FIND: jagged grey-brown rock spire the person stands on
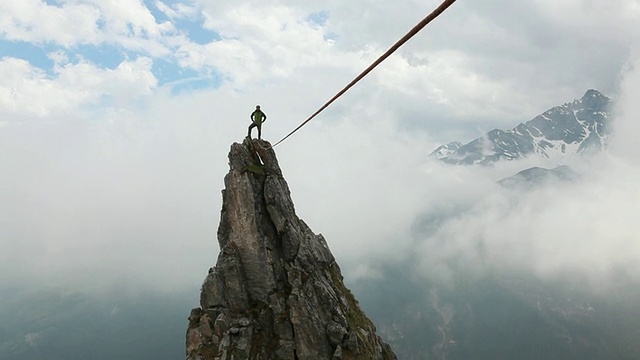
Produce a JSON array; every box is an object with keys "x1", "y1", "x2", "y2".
[{"x1": 186, "y1": 139, "x2": 396, "y2": 360}]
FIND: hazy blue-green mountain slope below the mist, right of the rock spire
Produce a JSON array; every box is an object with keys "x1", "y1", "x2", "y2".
[{"x1": 354, "y1": 258, "x2": 640, "y2": 360}]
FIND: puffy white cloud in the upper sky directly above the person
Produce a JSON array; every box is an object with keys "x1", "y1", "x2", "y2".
[{"x1": 178, "y1": 4, "x2": 342, "y2": 86}]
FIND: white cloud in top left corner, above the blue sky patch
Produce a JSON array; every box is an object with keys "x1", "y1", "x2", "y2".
[{"x1": 0, "y1": 0, "x2": 176, "y2": 56}]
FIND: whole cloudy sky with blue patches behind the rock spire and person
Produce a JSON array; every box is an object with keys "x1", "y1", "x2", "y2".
[{"x1": 0, "y1": 0, "x2": 640, "y2": 299}]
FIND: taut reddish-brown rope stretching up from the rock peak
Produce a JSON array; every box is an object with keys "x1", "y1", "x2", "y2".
[{"x1": 271, "y1": 0, "x2": 456, "y2": 148}]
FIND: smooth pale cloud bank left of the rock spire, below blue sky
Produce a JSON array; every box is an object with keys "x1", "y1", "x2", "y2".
[{"x1": 0, "y1": 90, "x2": 230, "y2": 289}]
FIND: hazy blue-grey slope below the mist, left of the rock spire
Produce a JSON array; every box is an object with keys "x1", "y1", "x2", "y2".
[{"x1": 0, "y1": 285, "x2": 193, "y2": 360}]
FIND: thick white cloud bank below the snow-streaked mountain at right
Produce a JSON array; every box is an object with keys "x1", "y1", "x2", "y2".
[{"x1": 412, "y1": 158, "x2": 640, "y2": 290}]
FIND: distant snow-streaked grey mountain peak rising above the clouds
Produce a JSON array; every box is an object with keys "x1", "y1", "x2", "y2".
[{"x1": 430, "y1": 90, "x2": 612, "y2": 165}]
